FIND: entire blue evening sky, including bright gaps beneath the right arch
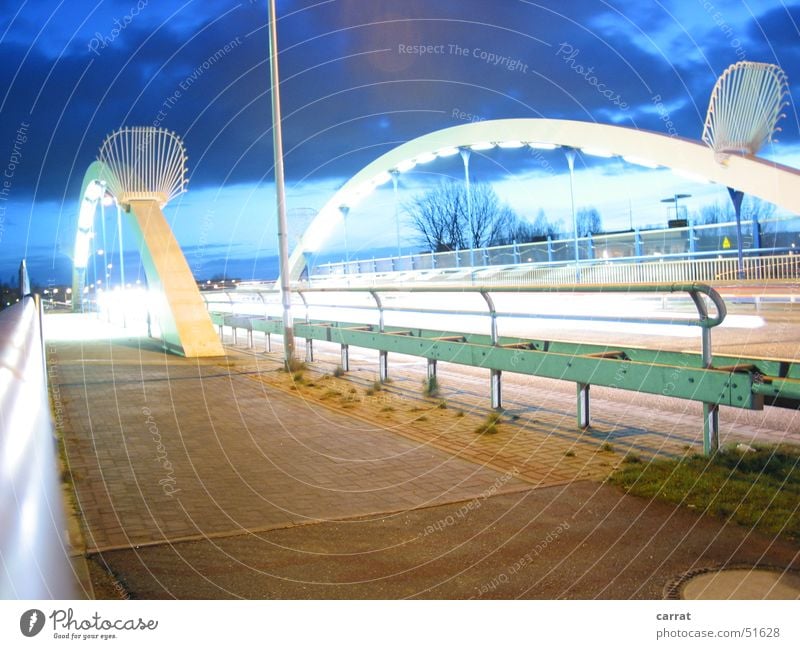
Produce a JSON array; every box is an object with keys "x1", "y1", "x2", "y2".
[{"x1": 0, "y1": 0, "x2": 800, "y2": 283}]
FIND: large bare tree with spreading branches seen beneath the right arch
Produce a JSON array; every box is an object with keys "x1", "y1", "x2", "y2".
[{"x1": 403, "y1": 181, "x2": 519, "y2": 252}]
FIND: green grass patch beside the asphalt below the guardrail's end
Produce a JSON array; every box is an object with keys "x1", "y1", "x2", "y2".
[{"x1": 609, "y1": 446, "x2": 800, "y2": 541}]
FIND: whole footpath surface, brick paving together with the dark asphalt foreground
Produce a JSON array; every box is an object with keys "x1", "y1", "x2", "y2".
[{"x1": 48, "y1": 318, "x2": 800, "y2": 598}]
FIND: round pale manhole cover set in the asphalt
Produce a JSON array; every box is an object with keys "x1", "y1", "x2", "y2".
[{"x1": 677, "y1": 568, "x2": 800, "y2": 599}]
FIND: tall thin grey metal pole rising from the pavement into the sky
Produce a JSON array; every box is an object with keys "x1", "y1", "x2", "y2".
[{"x1": 269, "y1": 0, "x2": 294, "y2": 370}]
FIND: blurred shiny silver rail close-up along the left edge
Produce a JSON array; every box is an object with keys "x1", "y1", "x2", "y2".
[{"x1": 0, "y1": 286, "x2": 75, "y2": 599}]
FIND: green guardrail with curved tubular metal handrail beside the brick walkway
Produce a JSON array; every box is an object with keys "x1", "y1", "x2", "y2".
[{"x1": 200, "y1": 283, "x2": 800, "y2": 452}]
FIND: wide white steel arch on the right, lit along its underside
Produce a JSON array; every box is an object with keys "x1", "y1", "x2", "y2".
[{"x1": 289, "y1": 118, "x2": 800, "y2": 281}]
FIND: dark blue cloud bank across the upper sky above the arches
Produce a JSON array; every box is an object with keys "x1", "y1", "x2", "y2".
[{"x1": 0, "y1": 0, "x2": 800, "y2": 274}]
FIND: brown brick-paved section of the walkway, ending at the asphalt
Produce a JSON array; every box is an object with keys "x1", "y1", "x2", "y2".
[{"x1": 50, "y1": 334, "x2": 528, "y2": 552}]
